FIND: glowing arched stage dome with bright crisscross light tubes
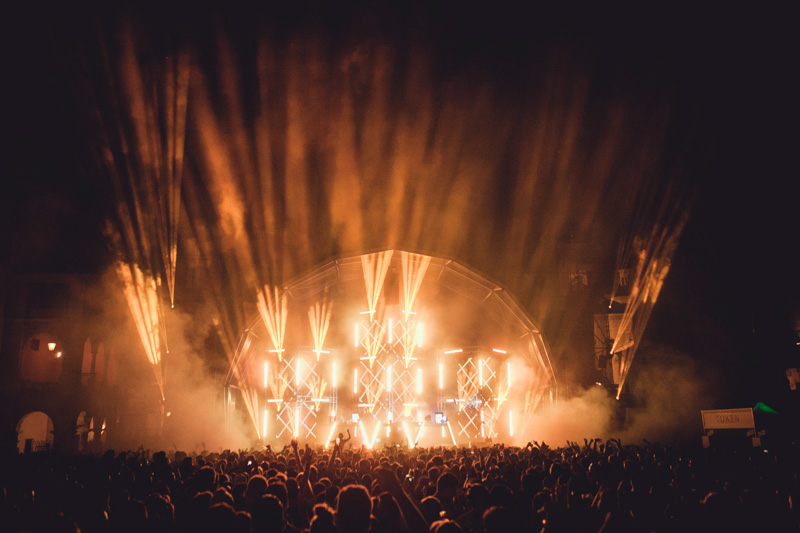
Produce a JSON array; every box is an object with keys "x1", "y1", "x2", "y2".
[{"x1": 224, "y1": 250, "x2": 557, "y2": 448}]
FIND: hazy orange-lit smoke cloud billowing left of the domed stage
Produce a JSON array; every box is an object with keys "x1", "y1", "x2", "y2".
[{"x1": 72, "y1": 268, "x2": 251, "y2": 452}]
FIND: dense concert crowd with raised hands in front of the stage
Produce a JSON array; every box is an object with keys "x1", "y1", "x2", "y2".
[{"x1": 0, "y1": 436, "x2": 800, "y2": 533}]
